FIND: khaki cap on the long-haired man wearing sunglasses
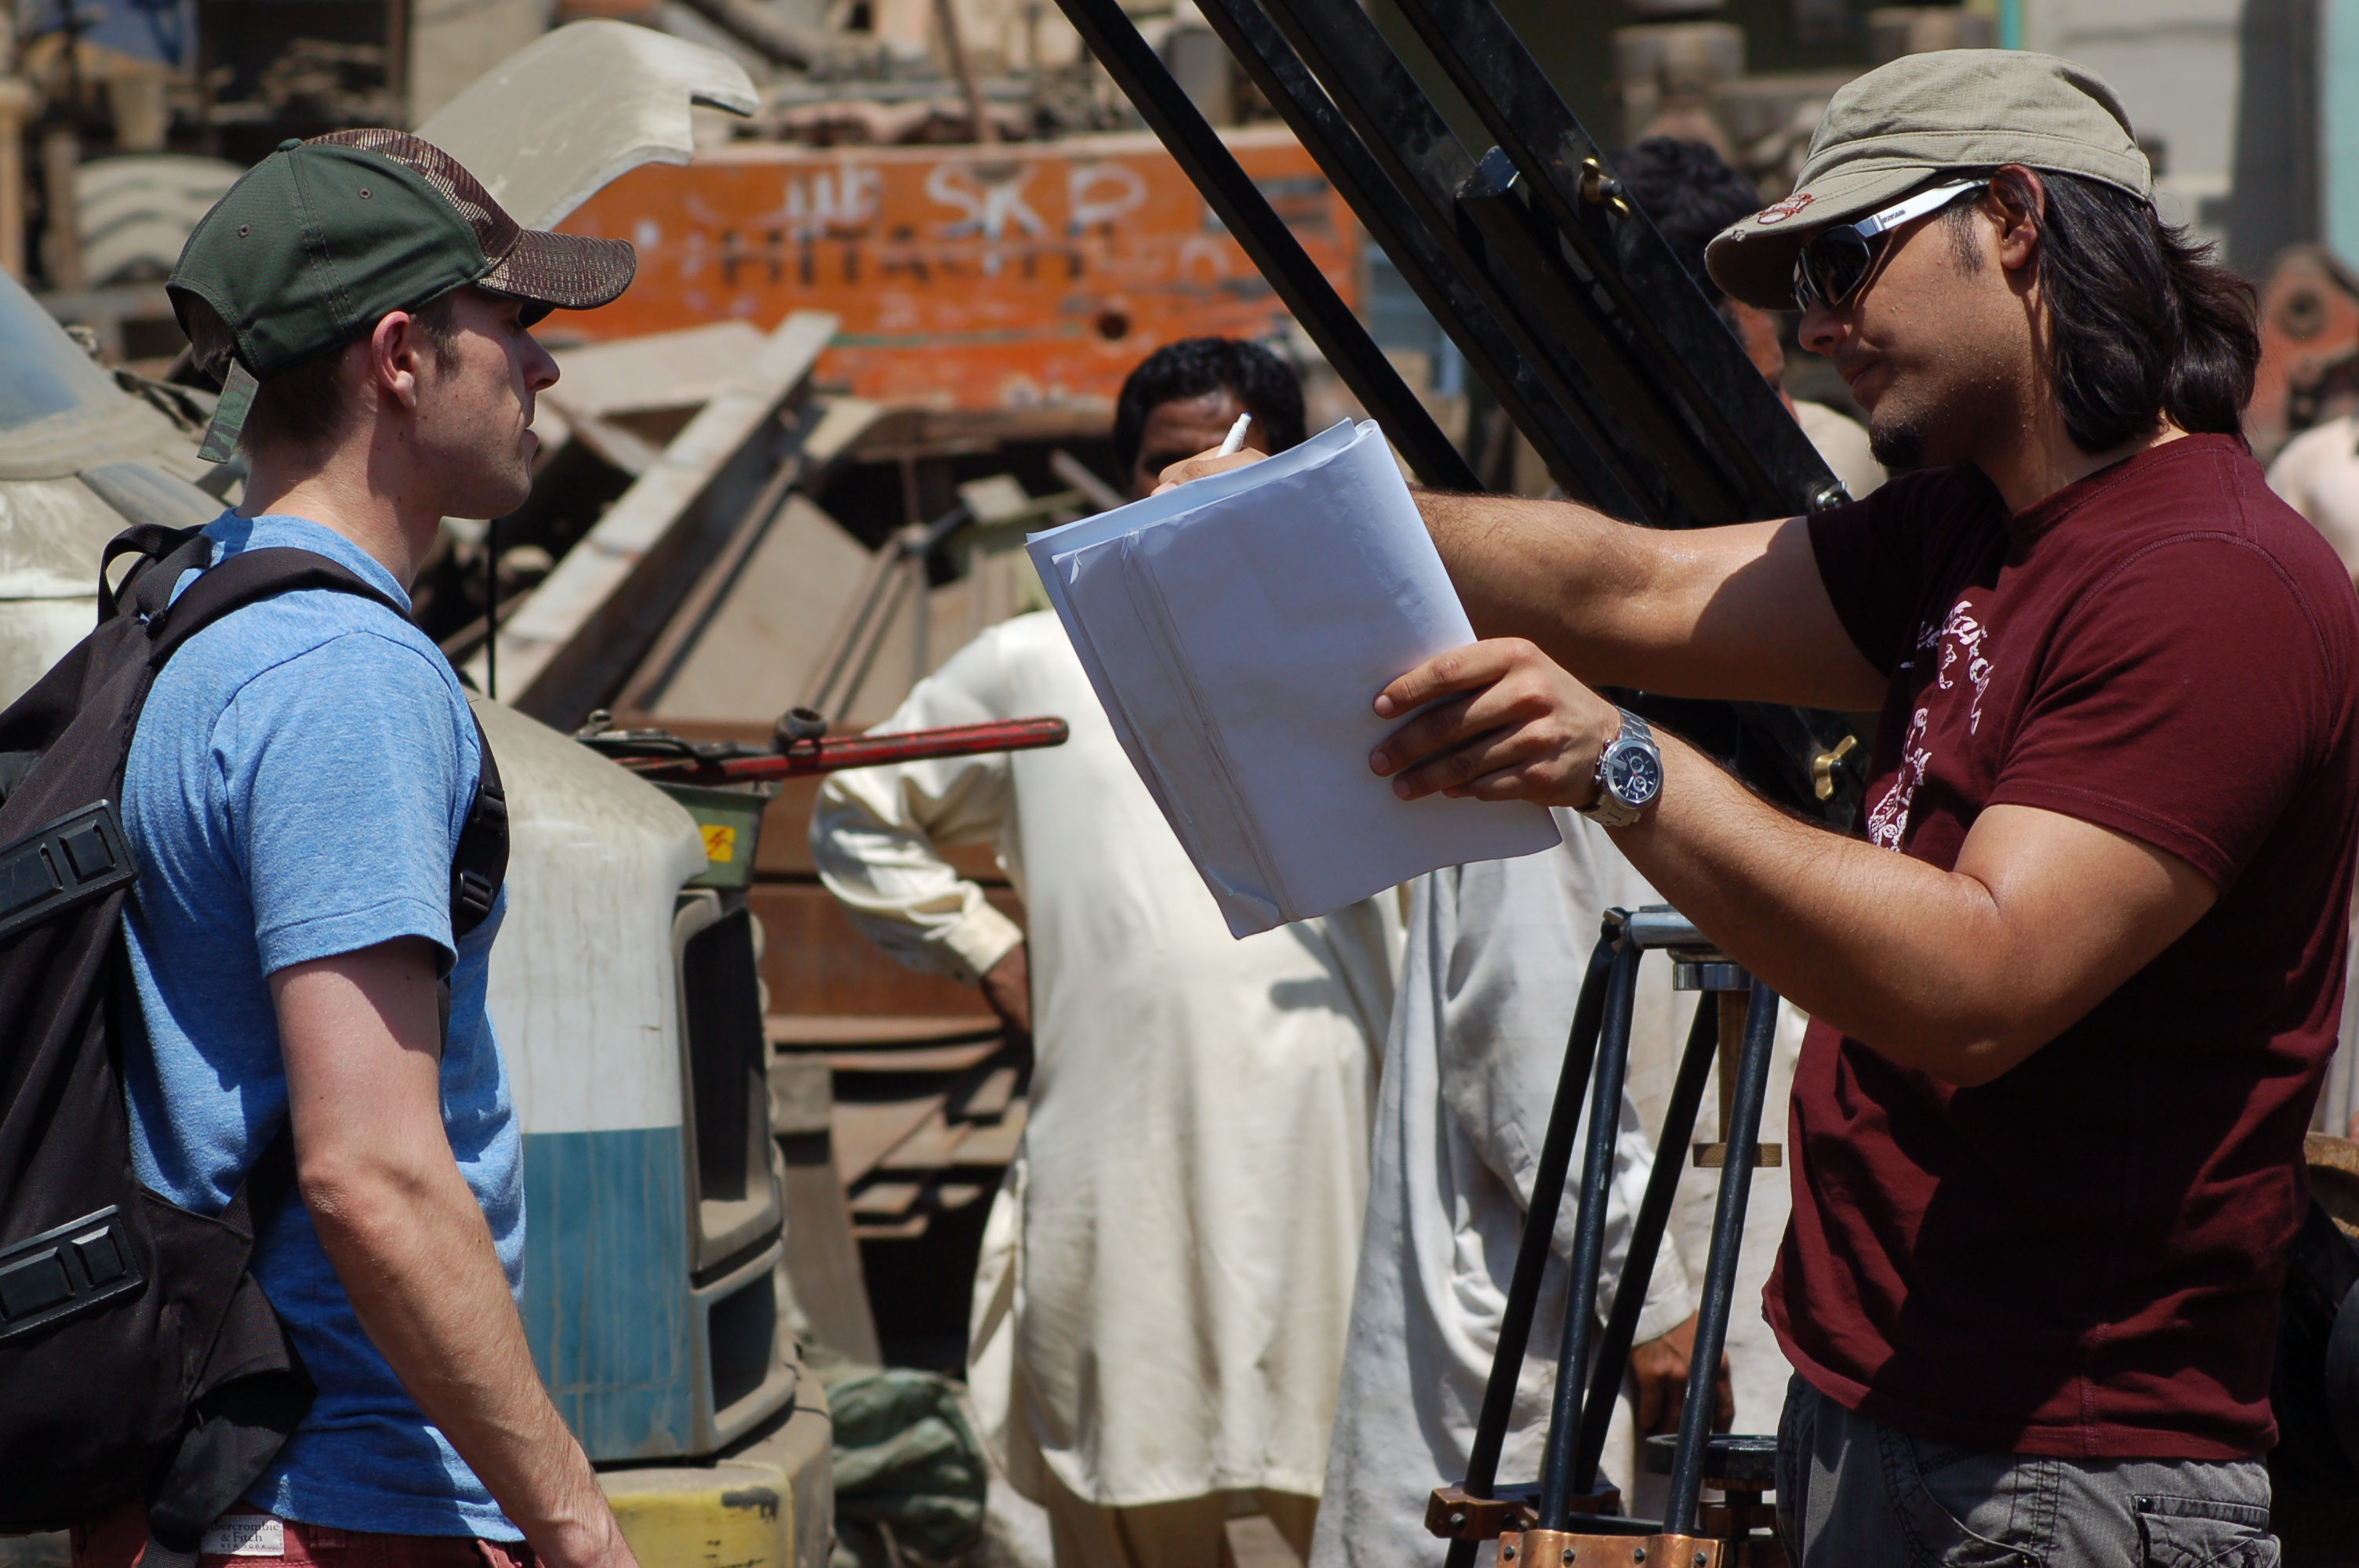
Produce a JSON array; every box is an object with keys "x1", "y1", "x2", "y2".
[{"x1": 1703, "y1": 49, "x2": 2154, "y2": 311}]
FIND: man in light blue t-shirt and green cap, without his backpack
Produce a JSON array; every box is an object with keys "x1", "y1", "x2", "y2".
[{"x1": 75, "y1": 129, "x2": 634, "y2": 1568}]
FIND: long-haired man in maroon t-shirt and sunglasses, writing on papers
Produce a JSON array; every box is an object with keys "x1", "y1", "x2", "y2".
[{"x1": 1170, "y1": 49, "x2": 2359, "y2": 1568}]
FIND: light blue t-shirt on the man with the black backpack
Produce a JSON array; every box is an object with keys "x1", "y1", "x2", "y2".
[{"x1": 122, "y1": 514, "x2": 524, "y2": 1540}]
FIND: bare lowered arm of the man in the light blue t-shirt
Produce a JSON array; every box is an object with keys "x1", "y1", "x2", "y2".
[{"x1": 271, "y1": 936, "x2": 637, "y2": 1568}]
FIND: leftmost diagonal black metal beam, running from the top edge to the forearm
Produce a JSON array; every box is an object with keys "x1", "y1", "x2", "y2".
[{"x1": 1057, "y1": 0, "x2": 1481, "y2": 491}]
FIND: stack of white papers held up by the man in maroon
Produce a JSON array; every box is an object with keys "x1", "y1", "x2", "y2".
[{"x1": 1026, "y1": 422, "x2": 1559, "y2": 936}]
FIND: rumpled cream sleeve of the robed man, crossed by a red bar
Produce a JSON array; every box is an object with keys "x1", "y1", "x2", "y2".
[{"x1": 812, "y1": 634, "x2": 1023, "y2": 981}]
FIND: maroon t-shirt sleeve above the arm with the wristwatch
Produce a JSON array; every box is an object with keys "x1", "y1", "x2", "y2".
[{"x1": 1989, "y1": 535, "x2": 2335, "y2": 889}]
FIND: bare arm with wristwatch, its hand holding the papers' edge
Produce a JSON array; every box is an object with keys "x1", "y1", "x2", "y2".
[{"x1": 1371, "y1": 639, "x2": 2220, "y2": 1084}]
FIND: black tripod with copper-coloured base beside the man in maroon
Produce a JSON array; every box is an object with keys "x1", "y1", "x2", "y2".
[{"x1": 1425, "y1": 908, "x2": 1786, "y2": 1568}]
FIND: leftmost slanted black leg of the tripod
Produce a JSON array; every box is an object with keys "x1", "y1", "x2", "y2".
[{"x1": 1448, "y1": 910, "x2": 1623, "y2": 1568}]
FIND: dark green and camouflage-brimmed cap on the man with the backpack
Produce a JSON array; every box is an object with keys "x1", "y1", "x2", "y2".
[{"x1": 165, "y1": 129, "x2": 639, "y2": 457}]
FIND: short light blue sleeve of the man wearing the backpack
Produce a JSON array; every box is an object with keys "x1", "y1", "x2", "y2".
[{"x1": 213, "y1": 632, "x2": 479, "y2": 974}]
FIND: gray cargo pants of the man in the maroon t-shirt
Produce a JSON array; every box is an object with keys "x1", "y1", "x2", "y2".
[{"x1": 1776, "y1": 1377, "x2": 2277, "y2": 1568}]
